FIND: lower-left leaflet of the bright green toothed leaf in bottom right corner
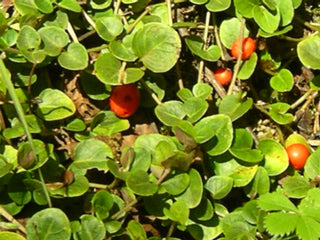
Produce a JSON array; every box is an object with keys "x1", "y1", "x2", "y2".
[{"x1": 264, "y1": 212, "x2": 299, "y2": 236}]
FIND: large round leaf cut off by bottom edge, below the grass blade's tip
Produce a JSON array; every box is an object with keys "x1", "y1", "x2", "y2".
[{"x1": 26, "y1": 208, "x2": 71, "y2": 240}]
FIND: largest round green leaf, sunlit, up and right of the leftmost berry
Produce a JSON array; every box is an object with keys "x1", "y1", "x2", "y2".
[{"x1": 132, "y1": 22, "x2": 181, "y2": 72}]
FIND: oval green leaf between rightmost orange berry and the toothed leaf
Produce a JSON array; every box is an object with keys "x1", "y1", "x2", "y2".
[{"x1": 283, "y1": 175, "x2": 311, "y2": 198}]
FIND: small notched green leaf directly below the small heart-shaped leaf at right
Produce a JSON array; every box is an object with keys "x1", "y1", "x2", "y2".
[{"x1": 269, "y1": 102, "x2": 293, "y2": 125}]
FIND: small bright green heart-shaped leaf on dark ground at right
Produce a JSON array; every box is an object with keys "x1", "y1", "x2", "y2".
[{"x1": 270, "y1": 69, "x2": 293, "y2": 92}]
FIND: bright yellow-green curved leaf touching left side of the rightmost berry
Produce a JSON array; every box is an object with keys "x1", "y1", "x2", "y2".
[{"x1": 258, "y1": 138, "x2": 289, "y2": 176}]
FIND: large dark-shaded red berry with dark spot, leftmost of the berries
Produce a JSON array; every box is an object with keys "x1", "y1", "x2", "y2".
[{"x1": 109, "y1": 84, "x2": 140, "y2": 118}]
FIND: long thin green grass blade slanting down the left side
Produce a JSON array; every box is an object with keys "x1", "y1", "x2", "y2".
[{"x1": 0, "y1": 58, "x2": 52, "y2": 207}]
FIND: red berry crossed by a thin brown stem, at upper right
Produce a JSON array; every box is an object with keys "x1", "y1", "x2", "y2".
[{"x1": 231, "y1": 37, "x2": 256, "y2": 60}]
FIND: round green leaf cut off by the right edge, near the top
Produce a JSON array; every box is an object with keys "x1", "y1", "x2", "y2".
[{"x1": 297, "y1": 36, "x2": 320, "y2": 69}]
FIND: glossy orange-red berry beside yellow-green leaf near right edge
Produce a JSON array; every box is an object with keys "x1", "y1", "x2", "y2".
[{"x1": 286, "y1": 143, "x2": 309, "y2": 170}]
